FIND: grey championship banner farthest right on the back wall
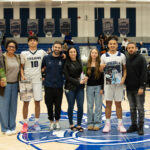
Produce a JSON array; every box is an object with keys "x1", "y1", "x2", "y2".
[{"x1": 118, "y1": 18, "x2": 130, "y2": 35}]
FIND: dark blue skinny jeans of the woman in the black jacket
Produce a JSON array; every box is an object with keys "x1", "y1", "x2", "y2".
[{"x1": 65, "y1": 88, "x2": 84, "y2": 126}]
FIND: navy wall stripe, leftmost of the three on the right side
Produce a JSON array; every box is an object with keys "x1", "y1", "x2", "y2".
[{"x1": 95, "y1": 8, "x2": 104, "y2": 36}]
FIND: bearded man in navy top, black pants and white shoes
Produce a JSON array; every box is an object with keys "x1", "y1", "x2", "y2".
[{"x1": 42, "y1": 41, "x2": 64, "y2": 130}]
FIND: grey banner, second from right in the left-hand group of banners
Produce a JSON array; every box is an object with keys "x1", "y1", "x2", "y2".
[{"x1": 43, "y1": 19, "x2": 55, "y2": 35}]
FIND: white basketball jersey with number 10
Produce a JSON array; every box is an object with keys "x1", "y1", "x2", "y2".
[{"x1": 20, "y1": 49, "x2": 47, "y2": 83}]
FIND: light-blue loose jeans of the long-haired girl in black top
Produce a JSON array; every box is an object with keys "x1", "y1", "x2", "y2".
[{"x1": 86, "y1": 85, "x2": 102, "y2": 127}]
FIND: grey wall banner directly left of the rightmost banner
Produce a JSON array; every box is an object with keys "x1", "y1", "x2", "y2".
[{"x1": 102, "y1": 18, "x2": 114, "y2": 35}]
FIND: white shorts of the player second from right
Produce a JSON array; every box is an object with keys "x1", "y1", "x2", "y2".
[{"x1": 104, "y1": 84, "x2": 125, "y2": 101}]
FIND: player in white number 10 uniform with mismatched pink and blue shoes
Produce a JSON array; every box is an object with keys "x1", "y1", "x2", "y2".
[{"x1": 21, "y1": 35, "x2": 47, "y2": 133}]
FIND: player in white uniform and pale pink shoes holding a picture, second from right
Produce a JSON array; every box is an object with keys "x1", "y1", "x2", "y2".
[{"x1": 100, "y1": 37, "x2": 126, "y2": 132}]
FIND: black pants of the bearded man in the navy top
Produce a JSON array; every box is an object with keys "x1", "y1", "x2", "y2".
[{"x1": 45, "y1": 87, "x2": 63, "y2": 121}]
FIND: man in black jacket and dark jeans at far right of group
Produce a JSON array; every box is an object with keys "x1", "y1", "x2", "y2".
[{"x1": 125, "y1": 42, "x2": 147, "y2": 135}]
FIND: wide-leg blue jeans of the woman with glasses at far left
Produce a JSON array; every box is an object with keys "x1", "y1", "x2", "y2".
[{"x1": 0, "y1": 83, "x2": 18, "y2": 132}]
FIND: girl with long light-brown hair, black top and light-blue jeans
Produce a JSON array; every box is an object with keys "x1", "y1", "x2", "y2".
[{"x1": 86, "y1": 49, "x2": 104, "y2": 130}]
